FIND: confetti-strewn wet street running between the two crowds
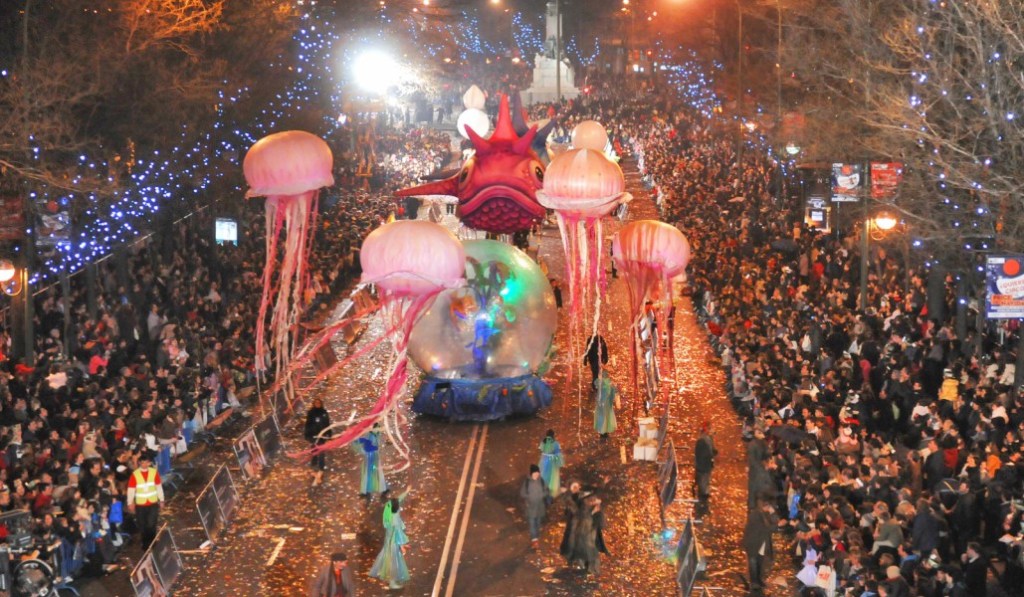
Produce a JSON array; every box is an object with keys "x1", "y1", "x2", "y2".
[{"x1": 163, "y1": 158, "x2": 745, "y2": 597}]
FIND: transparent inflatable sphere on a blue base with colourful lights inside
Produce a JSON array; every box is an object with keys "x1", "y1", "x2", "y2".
[{"x1": 409, "y1": 241, "x2": 557, "y2": 421}]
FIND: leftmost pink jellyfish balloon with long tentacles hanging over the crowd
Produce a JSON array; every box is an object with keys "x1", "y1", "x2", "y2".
[{"x1": 242, "y1": 131, "x2": 334, "y2": 378}]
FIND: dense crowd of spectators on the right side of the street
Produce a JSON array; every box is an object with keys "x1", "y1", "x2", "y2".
[{"x1": 635, "y1": 93, "x2": 1024, "y2": 597}]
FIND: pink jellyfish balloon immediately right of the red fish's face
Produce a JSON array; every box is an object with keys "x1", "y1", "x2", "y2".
[{"x1": 537, "y1": 145, "x2": 633, "y2": 378}]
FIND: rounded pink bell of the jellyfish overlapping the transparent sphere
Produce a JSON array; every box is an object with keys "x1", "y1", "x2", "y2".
[{"x1": 359, "y1": 220, "x2": 466, "y2": 297}]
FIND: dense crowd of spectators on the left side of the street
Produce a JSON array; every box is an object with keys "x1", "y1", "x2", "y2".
[{"x1": 0, "y1": 122, "x2": 449, "y2": 577}]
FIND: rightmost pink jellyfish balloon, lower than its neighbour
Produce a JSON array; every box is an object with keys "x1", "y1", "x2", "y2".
[{"x1": 611, "y1": 220, "x2": 690, "y2": 417}]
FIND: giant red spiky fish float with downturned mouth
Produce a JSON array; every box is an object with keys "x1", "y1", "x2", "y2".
[{"x1": 395, "y1": 95, "x2": 547, "y2": 234}]
